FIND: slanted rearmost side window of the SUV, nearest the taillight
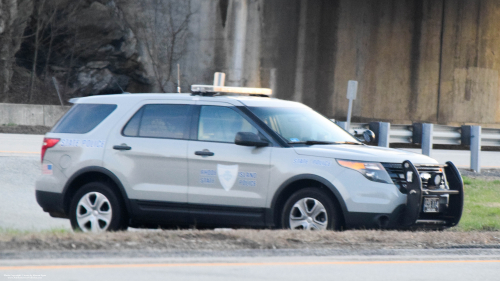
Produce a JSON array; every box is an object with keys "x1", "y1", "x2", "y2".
[{"x1": 51, "y1": 103, "x2": 116, "y2": 134}]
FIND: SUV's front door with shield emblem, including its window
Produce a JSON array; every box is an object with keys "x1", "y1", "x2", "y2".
[{"x1": 188, "y1": 102, "x2": 272, "y2": 225}]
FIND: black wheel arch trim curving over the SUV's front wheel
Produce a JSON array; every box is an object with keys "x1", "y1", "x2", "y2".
[{"x1": 266, "y1": 174, "x2": 348, "y2": 225}]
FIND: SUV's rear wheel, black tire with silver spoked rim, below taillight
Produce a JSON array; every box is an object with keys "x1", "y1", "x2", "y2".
[{"x1": 70, "y1": 182, "x2": 128, "y2": 232}]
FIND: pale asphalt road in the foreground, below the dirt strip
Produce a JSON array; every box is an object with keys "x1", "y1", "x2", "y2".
[{"x1": 0, "y1": 255, "x2": 500, "y2": 281}]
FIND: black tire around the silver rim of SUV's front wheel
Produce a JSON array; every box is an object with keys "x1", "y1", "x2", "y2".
[{"x1": 281, "y1": 187, "x2": 340, "y2": 230}]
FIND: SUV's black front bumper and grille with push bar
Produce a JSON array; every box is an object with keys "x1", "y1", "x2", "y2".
[{"x1": 345, "y1": 161, "x2": 464, "y2": 229}]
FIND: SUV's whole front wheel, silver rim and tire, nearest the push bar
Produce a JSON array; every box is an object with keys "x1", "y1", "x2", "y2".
[{"x1": 281, "y1": 188, "x2": 340, "y2": 230}]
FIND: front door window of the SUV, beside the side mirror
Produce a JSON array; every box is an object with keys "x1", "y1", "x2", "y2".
[{"x1": 198, "y1": 106, "x2": 258, "y2": 143}]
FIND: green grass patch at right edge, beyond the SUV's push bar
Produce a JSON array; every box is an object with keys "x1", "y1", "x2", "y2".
[{"x1": 456, "y1": 177, "x2": 500, "y2": 231}]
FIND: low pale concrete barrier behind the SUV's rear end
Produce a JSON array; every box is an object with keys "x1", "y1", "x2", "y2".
[{"x1": 0, "y1": 103, "x2": 71, "y2": 127}]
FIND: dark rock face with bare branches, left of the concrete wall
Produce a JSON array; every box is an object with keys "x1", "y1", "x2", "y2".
[{"x1": 7, "y1": 0, "x2": 152, "y2": 103}]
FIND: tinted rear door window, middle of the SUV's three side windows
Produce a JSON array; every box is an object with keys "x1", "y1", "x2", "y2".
[{"x1": 123, "y1": 104, "x2": 189, "y2": 139}]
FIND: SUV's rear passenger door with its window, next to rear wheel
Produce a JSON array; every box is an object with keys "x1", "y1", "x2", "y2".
[{"x1": 104, "y1": 100, "x2": 193, "y2": 221}]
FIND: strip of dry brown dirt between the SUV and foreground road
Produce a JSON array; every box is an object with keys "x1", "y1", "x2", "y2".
[{"x1": 0, "y1": 229, "x2": 500, "y2": 253}]
